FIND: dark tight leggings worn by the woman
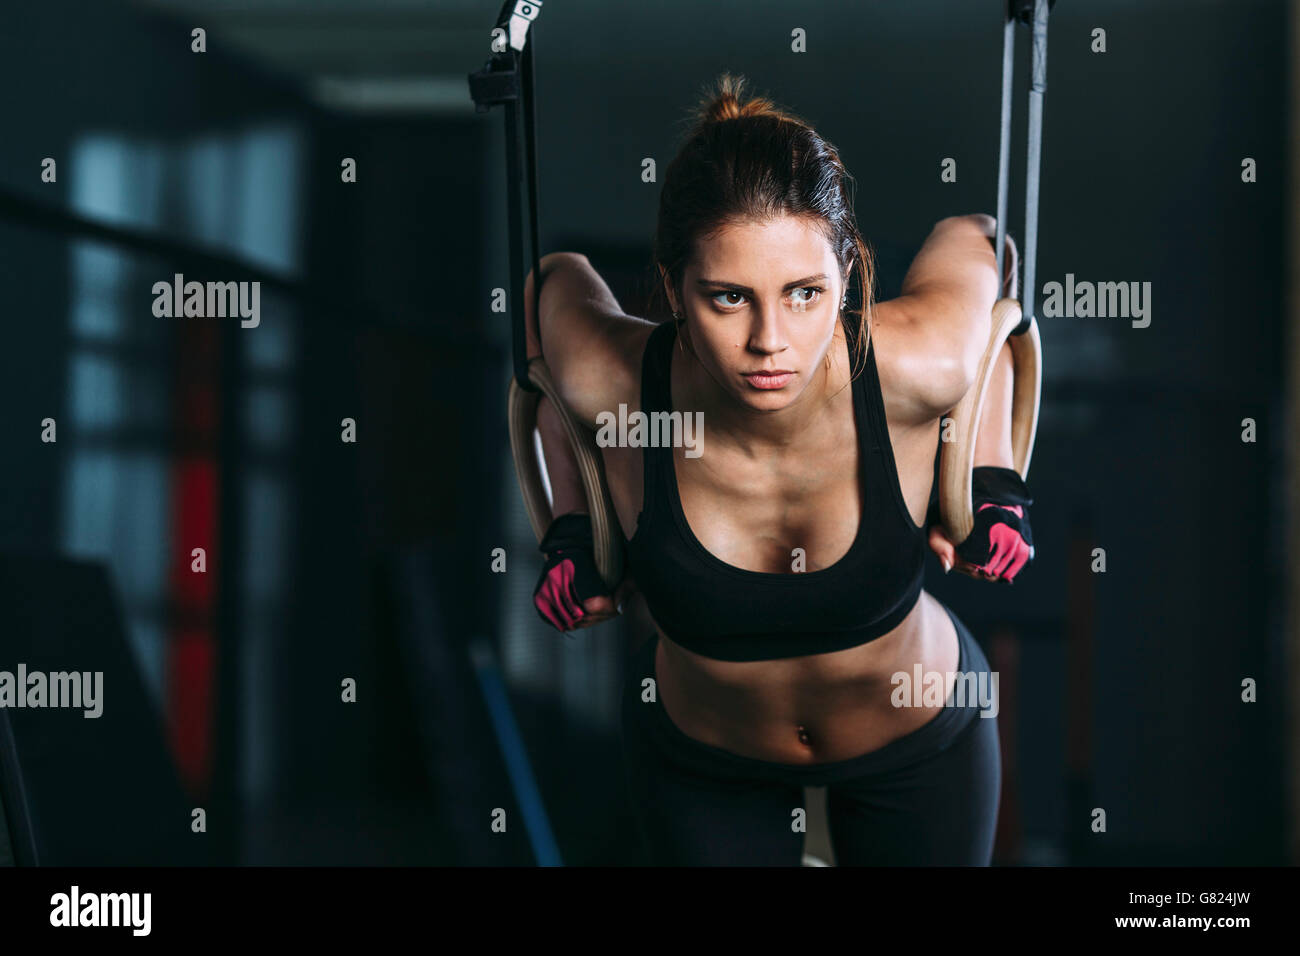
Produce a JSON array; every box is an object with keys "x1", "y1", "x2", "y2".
[{"x1": 623, "y1": 607, "x2": 1002, "y2": 866}]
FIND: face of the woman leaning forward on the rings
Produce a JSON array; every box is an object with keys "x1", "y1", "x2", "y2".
[{"x1": 675, "y1": 216, "x2": 844, "y2": 411}]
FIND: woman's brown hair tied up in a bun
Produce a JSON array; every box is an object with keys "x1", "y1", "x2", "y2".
[{"x1": 654, "y1": 73, "x2": 875, "y2": 376}]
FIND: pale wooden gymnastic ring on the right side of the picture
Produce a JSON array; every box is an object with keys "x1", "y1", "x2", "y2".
[{"x1": 939, "y1": 299, "x2": 1043, "y2": 545}]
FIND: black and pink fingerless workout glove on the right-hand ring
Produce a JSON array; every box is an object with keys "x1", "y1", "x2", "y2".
[{"x1": 957, "y1": 466, "x2": 1034, "y2": 581}]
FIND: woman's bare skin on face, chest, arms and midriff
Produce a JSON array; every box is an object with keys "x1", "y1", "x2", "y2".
[{"x1": 534, "y1": 216, "x2": 1011, "y2": 763}]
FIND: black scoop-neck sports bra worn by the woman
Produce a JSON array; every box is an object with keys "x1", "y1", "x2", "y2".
[{"x1": 628, "y1": 321, "x2": 926, "y2": 661}]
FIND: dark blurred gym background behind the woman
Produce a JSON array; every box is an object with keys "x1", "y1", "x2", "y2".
[{"x1": 0, "y1": 0, "x2": 1297, "y2": 864}]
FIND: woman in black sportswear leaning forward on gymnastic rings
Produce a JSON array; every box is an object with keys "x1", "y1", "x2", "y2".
[{"x1": 527, "y1": 75, "x2": 1031, "y2": 865}]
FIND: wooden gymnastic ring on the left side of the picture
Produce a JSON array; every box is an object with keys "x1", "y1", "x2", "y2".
[{"x1": 506, "y1": 356, "x2": 623, "y2": 594}]
